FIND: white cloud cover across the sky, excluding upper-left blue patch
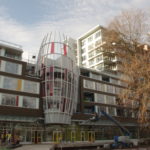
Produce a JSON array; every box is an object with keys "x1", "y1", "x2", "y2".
[{"x1": 0, "y1": 0, "x2": 149, "y2": 59}]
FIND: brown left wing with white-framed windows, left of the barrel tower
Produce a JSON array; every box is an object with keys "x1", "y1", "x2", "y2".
[{"x1": 0, "y1": 41, "x2": 43, "y2": 144}]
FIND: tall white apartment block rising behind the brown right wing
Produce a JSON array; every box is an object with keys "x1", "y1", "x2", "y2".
[{"x1": 77, "y1": 25, "x2": 118, "y2": 71}]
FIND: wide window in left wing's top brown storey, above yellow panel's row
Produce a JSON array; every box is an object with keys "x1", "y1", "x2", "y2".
[{"x1": 5, "y1": 61, "x2": 21, "y2": 75}]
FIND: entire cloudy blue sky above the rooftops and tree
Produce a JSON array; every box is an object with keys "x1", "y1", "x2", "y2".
[{"x1": 0, "y1": 0, "x2": 150, "y2": 58}]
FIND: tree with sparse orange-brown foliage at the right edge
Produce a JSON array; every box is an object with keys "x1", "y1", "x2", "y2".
[{"x1": 104, "y1": 10, "x2": 150, "y2": 123}]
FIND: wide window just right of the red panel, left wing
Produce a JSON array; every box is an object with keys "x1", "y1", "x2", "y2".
[{"x1": 22, "y1": 96, "x2": 39, "y2": 109}]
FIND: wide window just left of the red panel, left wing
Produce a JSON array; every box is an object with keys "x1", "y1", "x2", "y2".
[{"x1": 1, "y1": 94, "x2": 18, "y2": 106}]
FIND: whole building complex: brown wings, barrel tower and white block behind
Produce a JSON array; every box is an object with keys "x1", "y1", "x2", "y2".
[{"x1": 0, "y1": 30, "x2": 150, "y2": 143}]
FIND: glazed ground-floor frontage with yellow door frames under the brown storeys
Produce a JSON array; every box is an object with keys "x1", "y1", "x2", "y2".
[{"x1": 0, "y1": 122, "x2": 150, "y2": 144}]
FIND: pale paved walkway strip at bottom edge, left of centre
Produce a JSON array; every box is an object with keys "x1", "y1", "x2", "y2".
[{"x1": 15, "y1": 144, "x2": 53, "y2": 150}]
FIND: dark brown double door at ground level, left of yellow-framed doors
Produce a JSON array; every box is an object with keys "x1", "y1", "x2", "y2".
[{"x1": 32, "y1": 130, "x2": 42, "y2": 144}]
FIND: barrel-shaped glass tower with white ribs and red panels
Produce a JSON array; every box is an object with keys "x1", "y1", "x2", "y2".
[{"x1": 37, "y1": 32, "x2": 78, "y2": 124}]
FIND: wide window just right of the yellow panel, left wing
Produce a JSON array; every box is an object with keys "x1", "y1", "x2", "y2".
[{"x1": 24, "y1": 80, "x2": 39, "y2": 94}]
